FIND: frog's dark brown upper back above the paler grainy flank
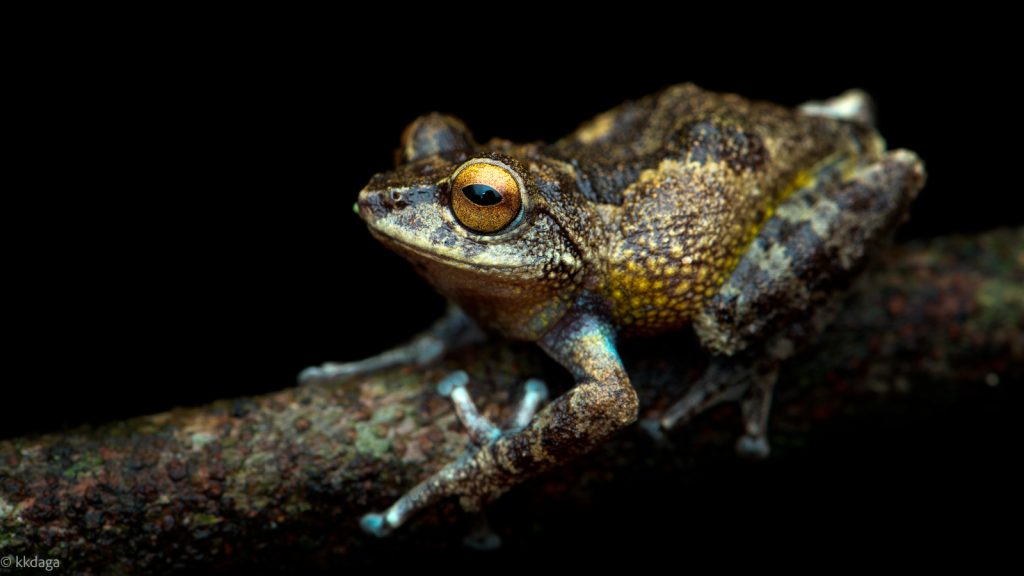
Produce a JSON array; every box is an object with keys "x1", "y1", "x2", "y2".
[{"x1": 550, "y1": 84, "x2": 881, "y2": 205}]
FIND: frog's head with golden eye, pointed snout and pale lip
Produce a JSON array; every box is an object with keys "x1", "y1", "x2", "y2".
[{"x1": 357, "y1": 114, "x2": 600, "y2": 338}]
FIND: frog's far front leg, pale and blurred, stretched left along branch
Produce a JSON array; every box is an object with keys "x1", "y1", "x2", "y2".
[{"x1": 298, "y1": 304, "x2": 483, "y2": 384}]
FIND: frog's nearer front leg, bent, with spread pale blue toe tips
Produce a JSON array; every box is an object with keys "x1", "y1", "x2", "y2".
[{"x1": 360, "y1": 316, "x2": 637, "y2": 536}]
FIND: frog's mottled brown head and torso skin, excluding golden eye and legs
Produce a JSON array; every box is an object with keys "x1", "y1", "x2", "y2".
[{"x1": 362, "y1": 84, "x2": 883, "y2": 340}]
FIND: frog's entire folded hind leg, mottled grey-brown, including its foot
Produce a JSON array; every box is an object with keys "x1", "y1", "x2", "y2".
[{"x1": 660, "y1": 151, "x2": 924, "y2": 456}]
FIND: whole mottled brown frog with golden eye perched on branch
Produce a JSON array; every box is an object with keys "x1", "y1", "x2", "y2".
[{"x1": 300, "y1": 84, "x2": 926, "y2": 536}]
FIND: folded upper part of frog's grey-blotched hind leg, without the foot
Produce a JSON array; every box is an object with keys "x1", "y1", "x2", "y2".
[{"x1": 694, "y1": 150, "x2": 925, "y2": 358}]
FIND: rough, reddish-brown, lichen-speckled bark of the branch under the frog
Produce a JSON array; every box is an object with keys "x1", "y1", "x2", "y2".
[{"x1": 0, "y1": 229, "x2": 1024, "y2": 573}]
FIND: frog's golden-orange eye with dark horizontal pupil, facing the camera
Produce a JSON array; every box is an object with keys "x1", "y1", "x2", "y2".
[{"x1": 452, "y1": 161, "x2": 522, "y2": 234}]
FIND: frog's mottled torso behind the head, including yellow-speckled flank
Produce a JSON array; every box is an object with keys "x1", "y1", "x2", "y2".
[{"x1": 550, "y1": 84, "x2": 884, "y2": 332}]
